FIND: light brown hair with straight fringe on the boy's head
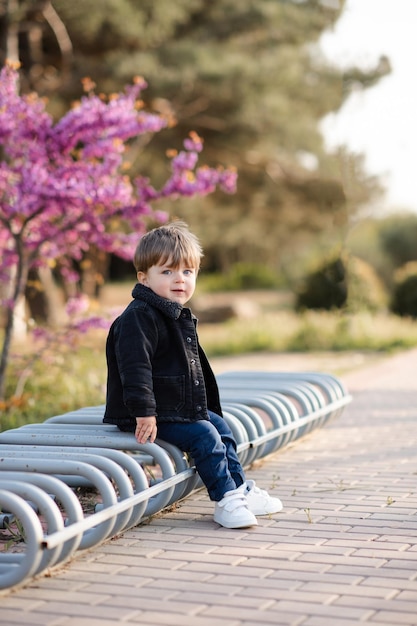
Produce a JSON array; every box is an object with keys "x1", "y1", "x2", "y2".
[{"x1": 133, "y1": 220, "x2": 203, "y2": 272}]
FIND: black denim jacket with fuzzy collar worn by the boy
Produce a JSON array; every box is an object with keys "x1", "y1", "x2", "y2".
[{"x1": 103, "y1": 284, "x2": 222, "y2": 430}]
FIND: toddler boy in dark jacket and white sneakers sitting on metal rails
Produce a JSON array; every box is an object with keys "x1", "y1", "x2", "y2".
[{"x1": 103, "y1": 221, "x2": 282, "y2": 528}]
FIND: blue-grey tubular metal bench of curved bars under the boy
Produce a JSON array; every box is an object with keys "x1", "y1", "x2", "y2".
[{"x1": 0, "y1": 371, "x2": 351, "y2": 589}]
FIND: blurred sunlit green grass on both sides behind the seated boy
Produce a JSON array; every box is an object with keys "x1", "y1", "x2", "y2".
[{"x1": 0, "y1": 307, "x2": 417, "y2": 430}]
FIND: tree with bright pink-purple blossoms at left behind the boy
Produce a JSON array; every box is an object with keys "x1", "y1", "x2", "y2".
[{"x1": 0, "y1": 64, "x2": 236, "y2": 398}]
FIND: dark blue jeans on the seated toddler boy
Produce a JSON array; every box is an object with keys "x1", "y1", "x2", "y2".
[{"x1": 158, "y1": 411, "x2": 245, "y2": 501}]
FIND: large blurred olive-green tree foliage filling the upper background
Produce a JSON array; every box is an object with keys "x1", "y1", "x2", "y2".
[{"x1": 0, "y1": 0, "x2": 389, "y2": 270}]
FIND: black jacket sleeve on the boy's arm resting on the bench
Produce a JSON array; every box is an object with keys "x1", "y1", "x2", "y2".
[{"x1": 114, "y1": 308, "x2": 158, "y2": 417}]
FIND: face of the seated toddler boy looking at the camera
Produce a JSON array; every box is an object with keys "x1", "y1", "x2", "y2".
[{"x1": 137, "y1": 259, "x2": 197, "y2": 306}]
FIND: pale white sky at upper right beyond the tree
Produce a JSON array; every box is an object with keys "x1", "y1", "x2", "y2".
[{"x1": 321, "y1": 0, "x2": 417, "y2": 211}]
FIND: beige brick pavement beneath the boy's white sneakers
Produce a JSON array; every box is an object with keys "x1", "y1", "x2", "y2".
[{"x1": 0, "y1": 350, "x2": 417, "y2": 626}]
